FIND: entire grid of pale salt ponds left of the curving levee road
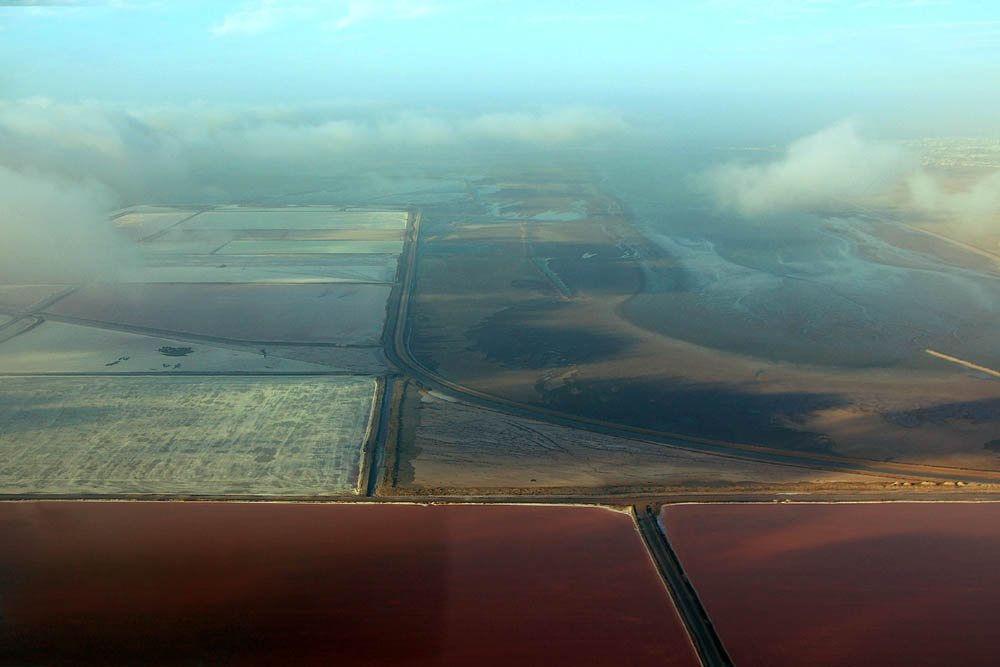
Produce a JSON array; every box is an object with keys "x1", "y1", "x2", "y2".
[{"x1": 0, "y1": 207, "x2": 408, "y2": 496}]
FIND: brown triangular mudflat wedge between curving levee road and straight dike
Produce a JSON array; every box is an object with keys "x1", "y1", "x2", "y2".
[{"x1": 385, "y1": 385, "x2": 891, "y2": 495}]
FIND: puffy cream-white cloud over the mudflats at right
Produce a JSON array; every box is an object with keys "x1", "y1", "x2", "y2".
[{"x1": 699, "y1": 121, "x2": 1000, "y2": 226}]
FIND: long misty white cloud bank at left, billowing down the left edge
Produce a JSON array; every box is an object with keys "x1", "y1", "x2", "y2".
[{"x1": 0, "y1": 99, "x2": 626, "y2": 281}]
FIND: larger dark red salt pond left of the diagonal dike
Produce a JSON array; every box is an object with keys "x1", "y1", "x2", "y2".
[{"x1": 0, "y1": 502, "x2": 697, "y2": 665}]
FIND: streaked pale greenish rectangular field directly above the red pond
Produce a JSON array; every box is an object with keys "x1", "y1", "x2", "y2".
[{"x1": 0, "y1": 377, "x2": 374, "y2": 496}]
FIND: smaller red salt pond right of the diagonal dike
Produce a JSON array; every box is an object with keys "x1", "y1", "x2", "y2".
[{"x1": 661, "y1": 503, "x2": 1000, "y2": 665}]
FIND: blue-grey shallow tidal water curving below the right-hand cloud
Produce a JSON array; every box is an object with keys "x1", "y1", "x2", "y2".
[{"x1": 601, "y1": 154, "x2": 1000, "y2": 366}]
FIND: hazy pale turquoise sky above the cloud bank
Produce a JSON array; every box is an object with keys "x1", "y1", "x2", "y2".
[{"x1": 0, "y1": 0, "x2": 1000, "y2": 137}]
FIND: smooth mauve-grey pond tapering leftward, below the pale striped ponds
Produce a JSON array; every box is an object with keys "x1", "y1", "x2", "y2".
[{"x1": 49, "y1": 283, "x2": 392, "y2": 345}]
